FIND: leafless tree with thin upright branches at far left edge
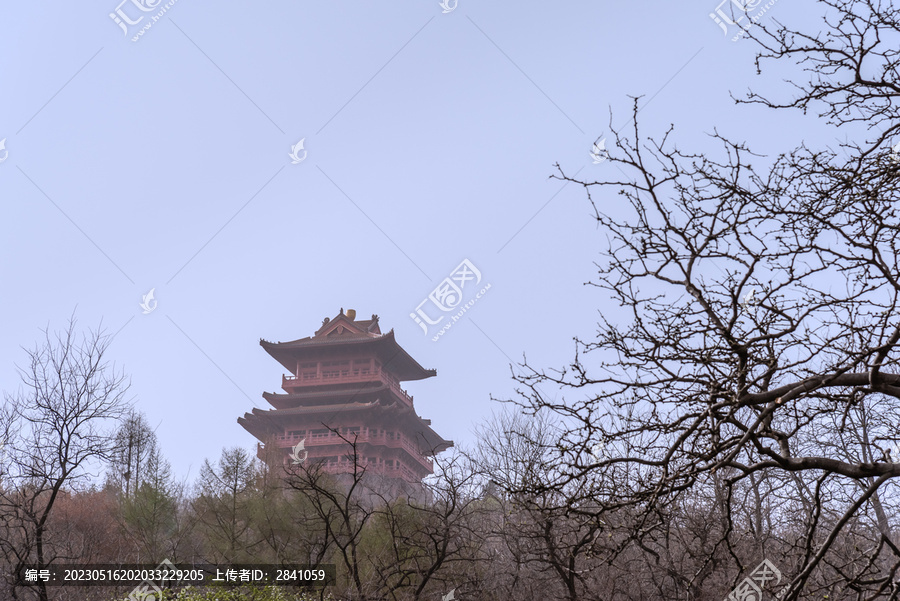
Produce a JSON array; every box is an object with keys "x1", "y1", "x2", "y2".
[{"x1": 0, "y1": 317, "x2": 128, "y2": 601}]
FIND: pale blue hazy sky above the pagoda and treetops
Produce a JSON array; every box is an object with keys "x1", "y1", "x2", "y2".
[{"x1": 0, "y1": 0, "x2": 833, "y2": 478}]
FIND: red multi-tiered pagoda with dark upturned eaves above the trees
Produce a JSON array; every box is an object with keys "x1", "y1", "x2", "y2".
[{"x1": 238, "y1": 309, "x2": 453, "y2": 484}]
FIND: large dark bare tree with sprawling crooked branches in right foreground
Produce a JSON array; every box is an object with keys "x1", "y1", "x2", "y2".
[{"x1": 502, "y1": 0, "x2": 900, "y2": 599}]
